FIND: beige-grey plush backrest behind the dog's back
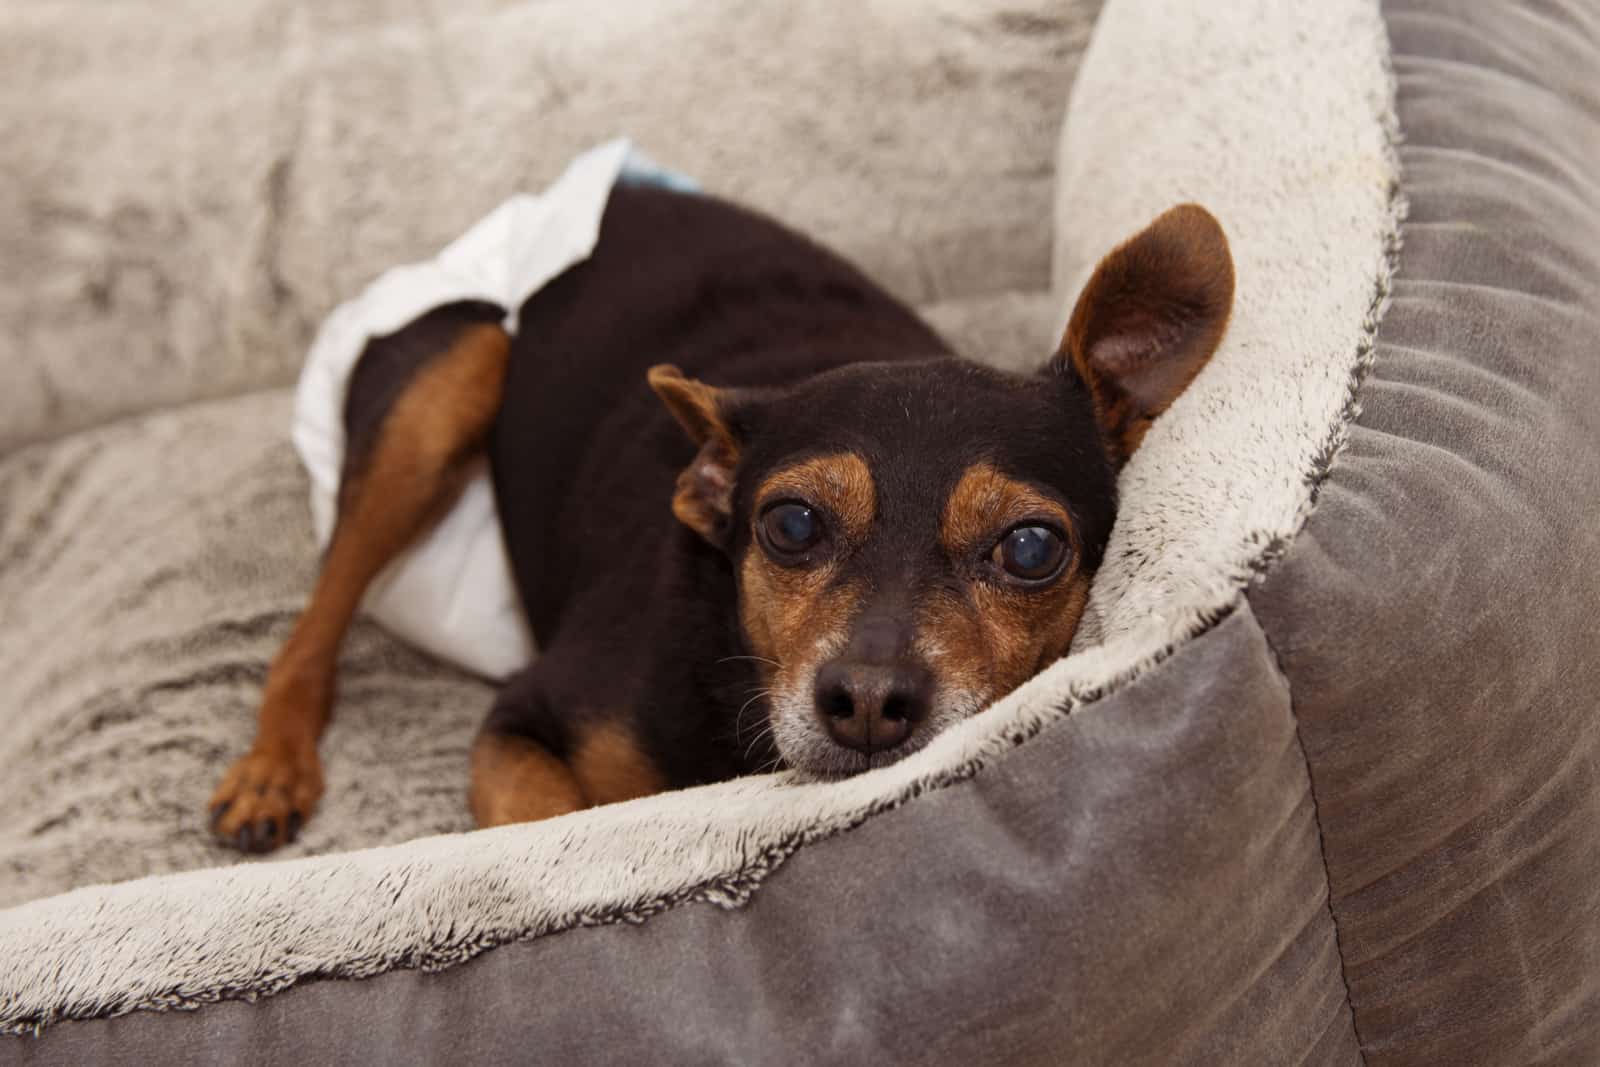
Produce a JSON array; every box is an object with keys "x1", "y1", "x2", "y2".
[{"x1": 0, "y1": 0, "x2": 1099, "y2": 453}]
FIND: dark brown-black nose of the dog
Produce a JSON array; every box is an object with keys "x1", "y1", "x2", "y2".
[{"x1": 816, "y1": 659, "x2": 933, "y2": 755}]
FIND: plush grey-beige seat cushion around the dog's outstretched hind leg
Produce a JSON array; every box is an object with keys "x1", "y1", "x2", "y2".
[{"x1": 0, "y1": 390, "x2": 491, "y2": 907}]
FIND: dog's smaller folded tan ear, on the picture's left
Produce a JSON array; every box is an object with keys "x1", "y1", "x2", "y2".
[{"x1": 645, "y1": 363, "x2": 739, "y2": 549}]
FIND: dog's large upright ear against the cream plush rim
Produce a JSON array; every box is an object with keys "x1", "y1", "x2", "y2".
[{"x1": 1051, "y1": 203, "x2": 1234, "y2": 466}]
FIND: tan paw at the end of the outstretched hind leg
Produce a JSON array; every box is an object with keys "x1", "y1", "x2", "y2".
[{"x1": 211, "y1": 749, "x2": 322, "y2": 853}]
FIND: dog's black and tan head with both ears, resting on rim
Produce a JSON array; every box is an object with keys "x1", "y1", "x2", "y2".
[{"x1": 650, "y1": 205, "x2": 1234, "y2": 776}]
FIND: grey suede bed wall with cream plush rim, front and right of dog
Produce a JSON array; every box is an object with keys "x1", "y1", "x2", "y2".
[{"x1": 0, "y1": 0, "x2": 1600, "y2": 1064}]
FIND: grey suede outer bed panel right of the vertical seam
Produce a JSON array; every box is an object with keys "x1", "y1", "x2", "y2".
[{"x1": 1251, "y1": 0, "x2": 1600, "y2": 1067}]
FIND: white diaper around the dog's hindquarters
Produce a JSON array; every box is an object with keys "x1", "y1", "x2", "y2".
[{"x1": 293, "y1": 139, "x2": 694, "y2": 678}]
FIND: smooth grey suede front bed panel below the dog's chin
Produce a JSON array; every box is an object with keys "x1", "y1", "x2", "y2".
[{"x1": 0, "y1": 608, "x2": 1358, "y2": 1067}]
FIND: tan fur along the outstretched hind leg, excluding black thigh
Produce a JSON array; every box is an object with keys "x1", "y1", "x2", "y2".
[{"x1": 211, "y1": 325, "x2": 510, "y2": 845}]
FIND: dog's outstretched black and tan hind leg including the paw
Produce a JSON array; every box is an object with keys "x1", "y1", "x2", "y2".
[{"x1": 211, "y1": 304, "x2": 510, "y2": 851}]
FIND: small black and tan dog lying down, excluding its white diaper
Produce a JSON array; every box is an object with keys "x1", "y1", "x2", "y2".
[{"x1": 211, "y1": 186, "x2": 1234, "y2": 851}]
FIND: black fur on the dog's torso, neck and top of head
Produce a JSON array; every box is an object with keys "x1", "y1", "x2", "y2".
[{"x1": 352, "y1": 186, "x2": 1115, "y2": 787}]
